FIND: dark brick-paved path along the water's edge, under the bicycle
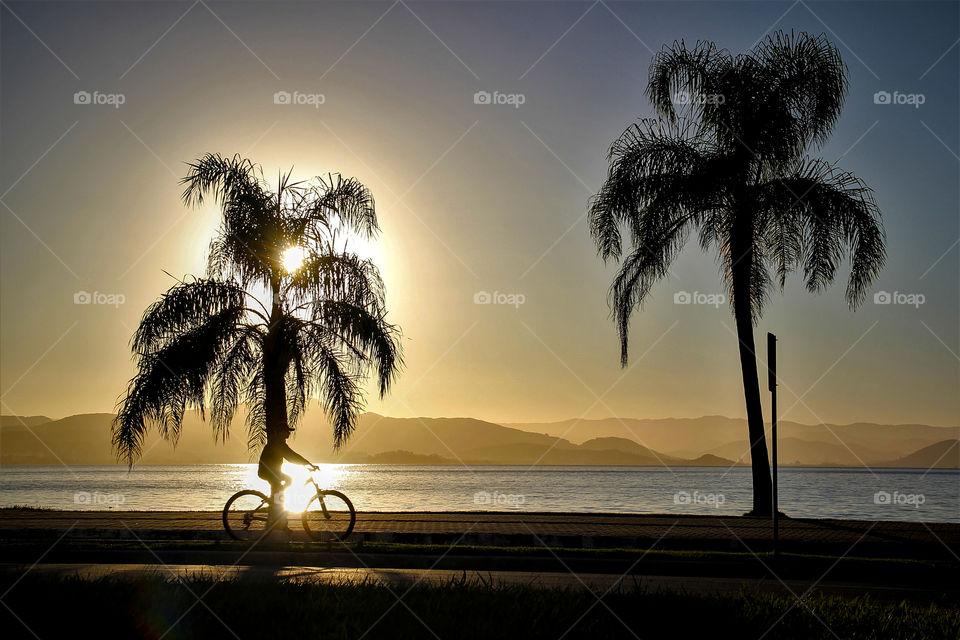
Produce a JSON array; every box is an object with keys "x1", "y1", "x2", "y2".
[{"x1": 0, "y1": 510, "x2": 960, "y2": 560}]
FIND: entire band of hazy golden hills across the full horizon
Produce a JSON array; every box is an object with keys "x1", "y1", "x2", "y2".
[{"x1": 0, "y1": 410, "x2": 960, "y2": 468}]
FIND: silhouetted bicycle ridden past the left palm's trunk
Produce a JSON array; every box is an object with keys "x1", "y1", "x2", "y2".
[{"x1": 223, "y1": 469, "x2": 357, "y2": 542}]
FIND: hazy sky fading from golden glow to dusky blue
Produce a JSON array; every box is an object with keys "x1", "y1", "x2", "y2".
[{"x1": 0, "y1": 2, "x2": 960, "y2": 425}]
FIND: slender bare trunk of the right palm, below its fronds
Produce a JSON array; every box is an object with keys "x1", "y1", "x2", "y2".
[{"x1": 731, "y1": 225, "x2": 773, "y2": 516}]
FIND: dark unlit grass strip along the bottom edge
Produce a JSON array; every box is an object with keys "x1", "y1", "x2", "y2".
[{"x1": 0, "y1": 574, "x2": 960, "y2": 640}]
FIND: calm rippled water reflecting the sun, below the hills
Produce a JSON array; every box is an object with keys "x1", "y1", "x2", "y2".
[{"x1": 0, "y1": 464, "x2": 960, "y2": 522}]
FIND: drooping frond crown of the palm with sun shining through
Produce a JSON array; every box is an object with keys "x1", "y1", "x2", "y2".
[{"x1": 113, "y1": 154, "x2": 401, "y2": 465}]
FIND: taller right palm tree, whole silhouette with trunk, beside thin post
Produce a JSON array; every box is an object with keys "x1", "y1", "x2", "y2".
[{"x1": 589, "y1": 32, "x2": 886, "y2": 515}]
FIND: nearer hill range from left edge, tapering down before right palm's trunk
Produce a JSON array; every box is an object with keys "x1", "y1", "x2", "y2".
[{"x1": 0, "y1": 412, "x2": 732, "y2": 466}]
